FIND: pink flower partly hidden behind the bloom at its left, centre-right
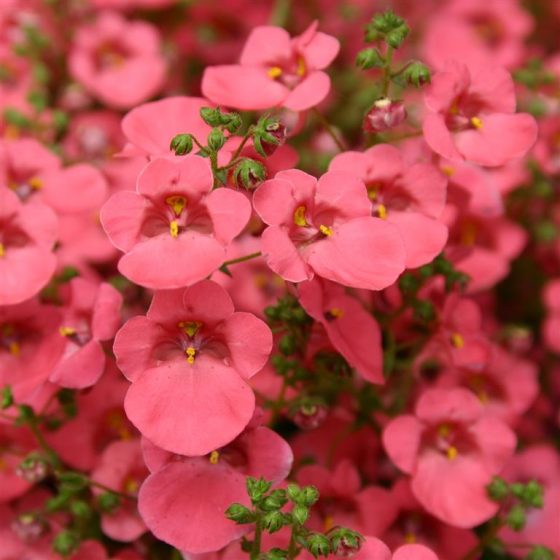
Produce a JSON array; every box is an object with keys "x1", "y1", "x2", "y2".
[{"x1": 329, "y1": 144, "x2": 447, "y2": 268}]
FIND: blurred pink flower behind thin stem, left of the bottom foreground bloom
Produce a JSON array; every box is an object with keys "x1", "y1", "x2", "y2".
[{"x1": 91, "y1": 439, "x2": 148, "y2": 542}]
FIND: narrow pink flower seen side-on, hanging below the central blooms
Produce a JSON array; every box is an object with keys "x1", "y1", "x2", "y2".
[{"x1": 299, "y1": 278, "x2": 385, "y2": 384}]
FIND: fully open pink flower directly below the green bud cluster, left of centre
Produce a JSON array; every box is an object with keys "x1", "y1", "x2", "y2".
[{"x1": 101, "y1": 155, "x2": 251, "y2": 289}]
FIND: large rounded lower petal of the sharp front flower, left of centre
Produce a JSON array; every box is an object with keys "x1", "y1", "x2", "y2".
[{"x1": 124, "y1": 357, "x2": 255, "y2": 456}]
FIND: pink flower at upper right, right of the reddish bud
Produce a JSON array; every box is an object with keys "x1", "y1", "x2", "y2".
[{"x1": 423, "y1": 61, "x2": 537, "y2": 167}]
